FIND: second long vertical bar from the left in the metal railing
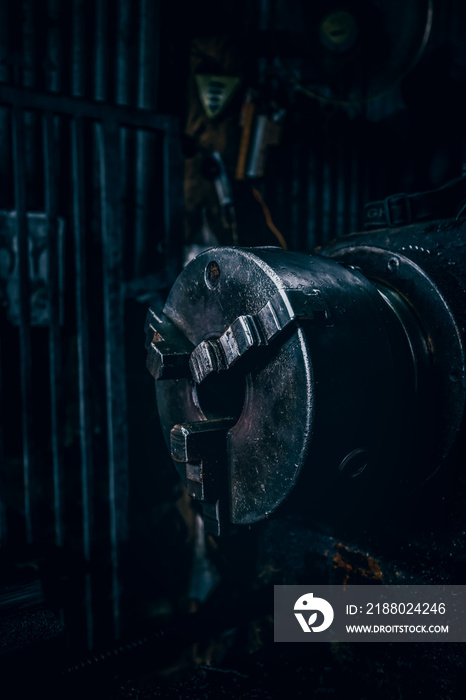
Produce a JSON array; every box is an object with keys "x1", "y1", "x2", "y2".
[{"x1": 42, "y1": 112, "x2": 64, "y2": 547}]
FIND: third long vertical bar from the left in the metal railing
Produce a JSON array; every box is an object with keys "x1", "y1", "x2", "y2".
[{"x1": 71, "y1": 118, "x2": 94, "y2": 648}]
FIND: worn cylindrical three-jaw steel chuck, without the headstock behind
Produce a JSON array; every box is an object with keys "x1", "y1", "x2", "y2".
[{"x1": 146, "y1": 247, "x2": 452, "y2": 535}]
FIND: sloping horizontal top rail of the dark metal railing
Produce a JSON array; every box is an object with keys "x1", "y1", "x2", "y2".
[{"x1": 0, "y1": 85, "x2": 176, "y2": 131}]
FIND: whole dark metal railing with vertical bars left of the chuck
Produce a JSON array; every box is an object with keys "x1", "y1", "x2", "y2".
[{"x1": 0, "y1": 85, "x2": 183, "y2": 646}]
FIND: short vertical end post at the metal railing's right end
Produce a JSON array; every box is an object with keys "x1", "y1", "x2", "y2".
[{"x1": 163, "y1": 118, "x2": 184, "y2": 281}]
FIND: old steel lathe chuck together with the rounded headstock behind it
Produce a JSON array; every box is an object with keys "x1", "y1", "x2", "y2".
[{"x1": 146, "y1": 222, "x2": 466, "y2": 534}]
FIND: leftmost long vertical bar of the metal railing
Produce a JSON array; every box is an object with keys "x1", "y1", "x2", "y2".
[{"x1": 12, "y1": 107, "x2": 38, "y2": 543}]
